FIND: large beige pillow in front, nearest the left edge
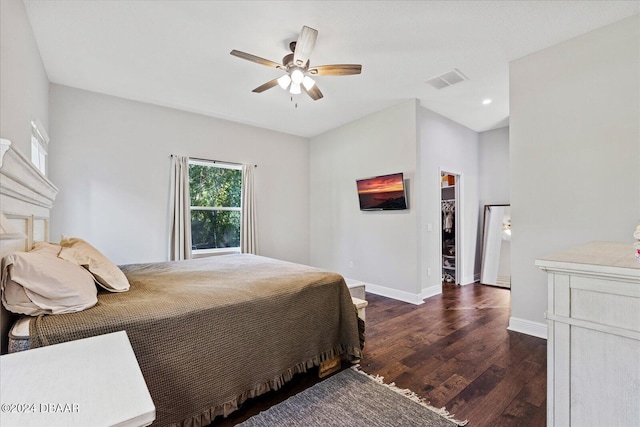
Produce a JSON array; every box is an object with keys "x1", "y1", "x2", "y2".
[{"x1": 2, "y1": 251, "x2": 98, "y2": 316}]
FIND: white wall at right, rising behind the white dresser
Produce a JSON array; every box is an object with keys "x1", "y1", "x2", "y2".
[{"x1": 510, "y1": 15, "x2": 640, "y2": 335}]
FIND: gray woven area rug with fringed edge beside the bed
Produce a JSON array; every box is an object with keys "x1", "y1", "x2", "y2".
[{"x1": 239, "y1": 368, "x2": 466, "y2": 427}]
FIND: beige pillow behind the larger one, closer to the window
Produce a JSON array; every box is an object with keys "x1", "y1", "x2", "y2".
[{"x1": 58, "y1": 237, "x2": 129, "y2": 292}]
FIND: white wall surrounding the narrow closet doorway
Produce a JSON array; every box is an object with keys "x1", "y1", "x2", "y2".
[{"x1": 418, "y1": 107, "x2": 479, "y2": 295}]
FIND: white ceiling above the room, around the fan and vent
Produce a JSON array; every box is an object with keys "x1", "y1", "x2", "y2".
[{"x1": 25, "y1": 0, "x2": 640, "y2": 137}]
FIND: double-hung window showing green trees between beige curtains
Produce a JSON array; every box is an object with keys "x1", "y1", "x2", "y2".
[{"x1": 189, "y1": 160, "x2": 242, "y2": 253}]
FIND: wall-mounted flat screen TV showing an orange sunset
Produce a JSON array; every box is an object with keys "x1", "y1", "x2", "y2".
[{"x1": 356, "y1": 172, "x2": 407, "y2": 211}]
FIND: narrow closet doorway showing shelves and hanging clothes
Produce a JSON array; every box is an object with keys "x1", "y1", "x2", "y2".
[{"x1": 440, "y1": 170, "x2": 462, "y2": 285}]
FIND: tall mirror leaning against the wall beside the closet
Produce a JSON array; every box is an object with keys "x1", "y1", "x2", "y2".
[{"x1": 480, "y1": 205, "x2": 511, "y2": 288}]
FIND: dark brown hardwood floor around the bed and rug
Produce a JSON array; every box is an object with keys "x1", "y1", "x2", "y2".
[{"x1": 211, "y1": 284, "x2": 546, "y2": 427}]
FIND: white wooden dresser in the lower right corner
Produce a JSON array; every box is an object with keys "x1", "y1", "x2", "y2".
[{"x1": 536, "y1": 242, "x2": 640, "y2": 427}]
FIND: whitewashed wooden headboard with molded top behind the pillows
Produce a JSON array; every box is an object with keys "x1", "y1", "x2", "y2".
[{"x1": 0, "y1": 139, "x2": 58, "y2": 354}]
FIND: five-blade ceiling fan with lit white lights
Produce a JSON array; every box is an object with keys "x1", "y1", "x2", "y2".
[{"x1": 231, "y1": 26, "x2": 362, "y2": 101}]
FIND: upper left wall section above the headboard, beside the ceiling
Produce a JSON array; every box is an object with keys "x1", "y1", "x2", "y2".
[{"x1": 0, "y1": 0, "x2": 49, "y2": 158}]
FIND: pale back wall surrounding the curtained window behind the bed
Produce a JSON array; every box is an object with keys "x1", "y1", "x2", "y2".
[{"x1": 50, "y1": 84, "x2": 309, "y2": 264}]
